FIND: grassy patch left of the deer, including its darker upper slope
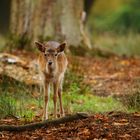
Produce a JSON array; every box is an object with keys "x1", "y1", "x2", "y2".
[{"x1": 0, "y1": 76, "x2": 39, "y2": 119}]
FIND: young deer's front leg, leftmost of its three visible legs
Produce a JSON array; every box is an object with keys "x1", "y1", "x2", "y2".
[{"x1": 44, "y1": 83, "x2": 50, "y2": 119}]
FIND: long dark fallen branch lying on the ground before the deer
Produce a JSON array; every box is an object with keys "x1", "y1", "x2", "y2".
[{"x1": 0, "y1": 113, "x2": 88, "y2": 132}]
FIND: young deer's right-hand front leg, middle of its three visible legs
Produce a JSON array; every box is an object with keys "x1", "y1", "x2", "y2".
[{"x1": 53, "y1": 81, "x2": 59, "y2": 118}]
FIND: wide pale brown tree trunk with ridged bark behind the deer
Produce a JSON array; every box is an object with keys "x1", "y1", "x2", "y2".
[{"x1": 10, "y1": 0, "x2": 91, "y2": 48}]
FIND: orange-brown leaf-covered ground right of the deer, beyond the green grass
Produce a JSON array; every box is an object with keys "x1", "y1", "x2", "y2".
[{"x1": 69, "y1": 57, "x2": 140, "y2": 96}]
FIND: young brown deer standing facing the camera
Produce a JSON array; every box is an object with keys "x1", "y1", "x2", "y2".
[{"x1": 35, "y1": 41, "x2": 68, "y2": 119}]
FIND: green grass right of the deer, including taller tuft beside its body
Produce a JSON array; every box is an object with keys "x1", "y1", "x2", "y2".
[{"x1": 63, "y1": 72, "x2": 126, "y2": 113}]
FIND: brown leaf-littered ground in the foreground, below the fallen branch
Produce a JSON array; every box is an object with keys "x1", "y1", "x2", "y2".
[{"x1": 0, "y1": 112, "x2": 140, "y2": 140}]
